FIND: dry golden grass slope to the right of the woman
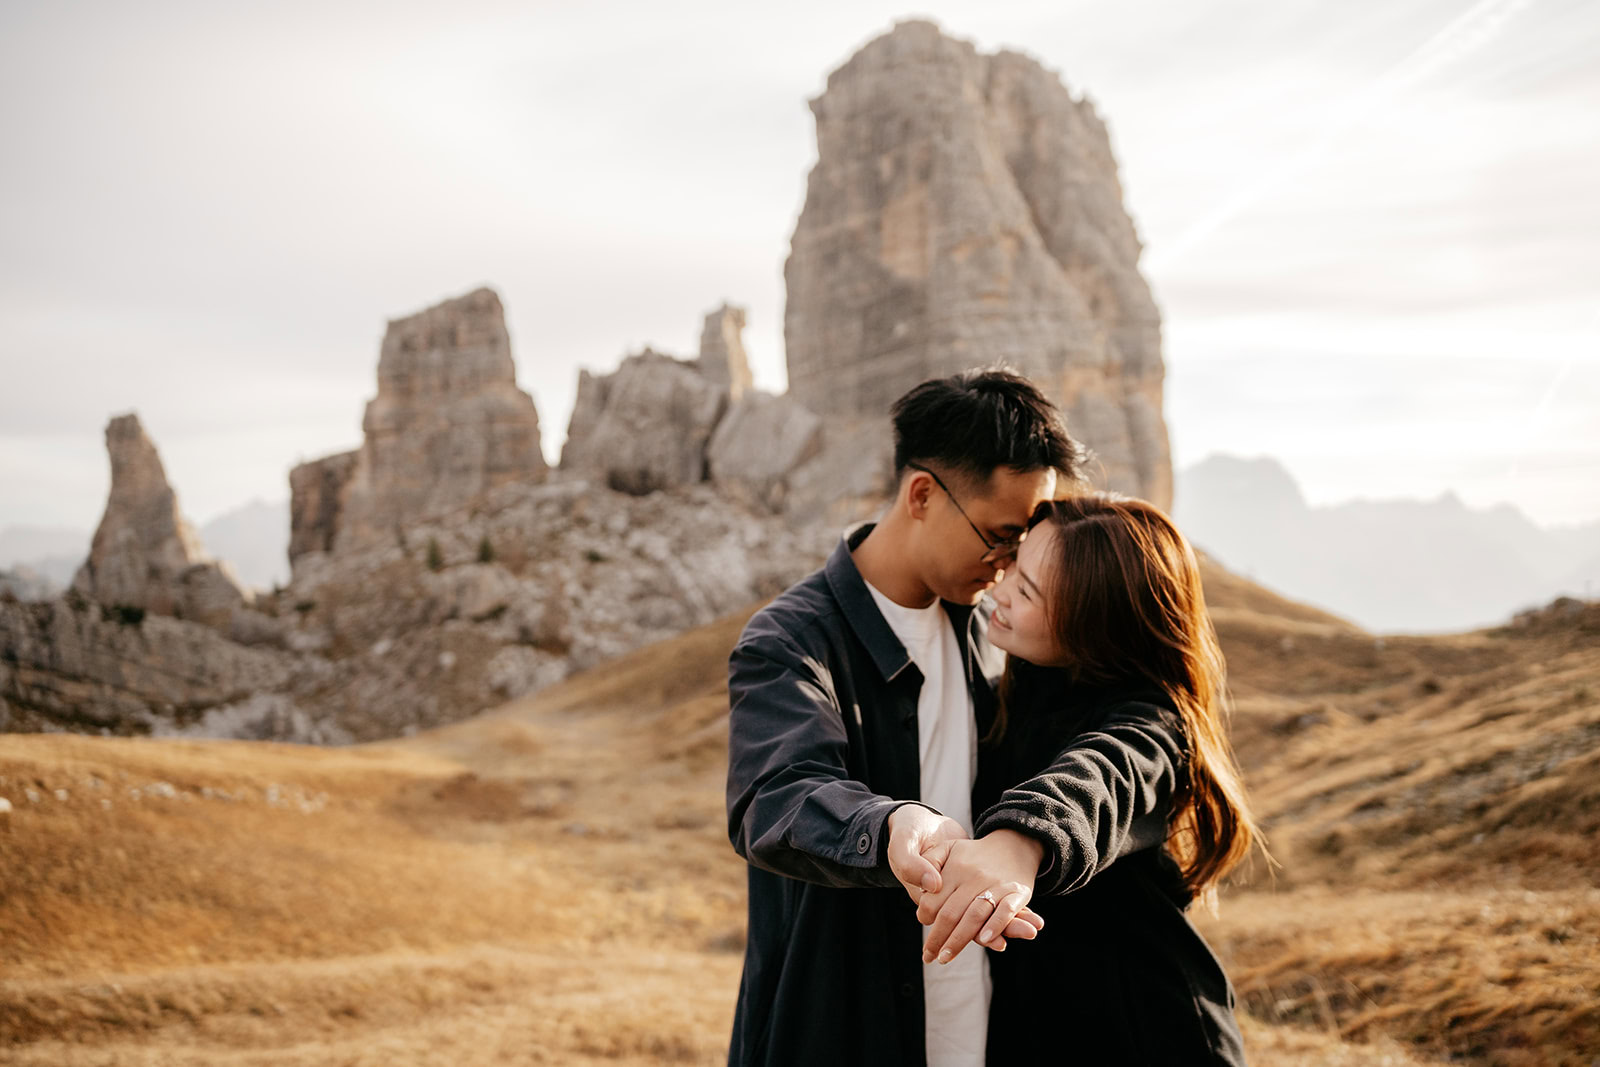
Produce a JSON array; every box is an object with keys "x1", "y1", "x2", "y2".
[{"x1": 1202, "y1": 605, "x2": 1600, "y2": 1067}]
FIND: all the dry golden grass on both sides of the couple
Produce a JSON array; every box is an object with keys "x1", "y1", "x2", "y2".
[{"x1": 0, "y1": 591, "x2": 1600, "y2": 1067}]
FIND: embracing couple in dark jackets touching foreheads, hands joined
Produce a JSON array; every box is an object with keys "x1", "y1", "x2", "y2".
[{"x1": 728, "y1": 371, "x2": 1259, "y2": 1067}]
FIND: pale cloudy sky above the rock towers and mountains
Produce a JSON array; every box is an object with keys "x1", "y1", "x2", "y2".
[{"x1": 0, "y1": 0, "x2": 1600, "y2": 530}]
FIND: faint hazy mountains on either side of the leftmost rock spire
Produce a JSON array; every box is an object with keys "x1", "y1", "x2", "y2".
[{"x1": 0, "y1": 501, "x2": 290, "y2": 595}]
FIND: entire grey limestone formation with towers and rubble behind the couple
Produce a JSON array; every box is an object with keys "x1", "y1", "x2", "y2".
[{"x1": 0, "y1": 22, "x2": 1190, "y2": 744}]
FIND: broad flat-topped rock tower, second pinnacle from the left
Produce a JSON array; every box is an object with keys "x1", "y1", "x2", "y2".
[{"x1": 290, "y1": 288, "x2": 547, "y2": 558}]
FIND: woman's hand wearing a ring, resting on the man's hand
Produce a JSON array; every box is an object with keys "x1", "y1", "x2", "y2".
[{"x1": 917, "y1": 830, "x2": 1045, "y2": 963}]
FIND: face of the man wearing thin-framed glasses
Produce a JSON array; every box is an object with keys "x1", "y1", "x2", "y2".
[{"x1": 920, "y1": 467, "x2": 1056, "y2": 605}]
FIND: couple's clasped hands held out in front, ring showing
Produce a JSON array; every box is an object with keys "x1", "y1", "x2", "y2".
[{"x1": 888, "y1": 805, "x2": 1045, "y2": 963}]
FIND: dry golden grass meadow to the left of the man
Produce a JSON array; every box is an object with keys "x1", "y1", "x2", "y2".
[{"x1": 0, "y1": 619, "x2": 744, "y2": 1067}]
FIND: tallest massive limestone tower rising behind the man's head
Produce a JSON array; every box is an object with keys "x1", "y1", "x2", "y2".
[{"x1": 784, "y1": 21, "x2": 1173, "y2": 507}]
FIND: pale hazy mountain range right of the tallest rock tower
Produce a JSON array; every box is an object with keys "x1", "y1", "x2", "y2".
[{"x1": 1173, "y1": 456, "x2": 1600, "y2": 632}]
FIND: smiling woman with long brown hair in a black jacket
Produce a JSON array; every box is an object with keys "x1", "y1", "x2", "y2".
[{"x1": 918, "y1": 494, "x2": 1261, "y2": 1065}]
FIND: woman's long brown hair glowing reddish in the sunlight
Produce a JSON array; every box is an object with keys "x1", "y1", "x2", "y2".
[{"x1": 990, "y1": 493, "x2": 1262, "y2": 905}]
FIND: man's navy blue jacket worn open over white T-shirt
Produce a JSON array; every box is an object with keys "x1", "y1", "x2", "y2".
[{"x1": 728, "y1": 526, "x2": 1000, "y2": 1067}]
